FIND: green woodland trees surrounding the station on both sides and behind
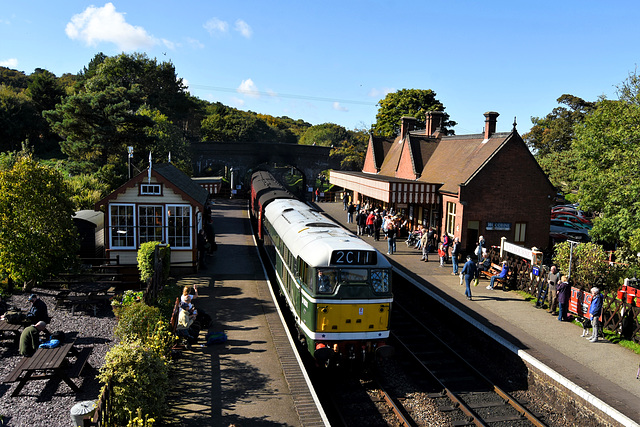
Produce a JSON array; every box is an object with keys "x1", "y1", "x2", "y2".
[{"x1": 0, "y1": 53, "x2": 640, "y2": 288}]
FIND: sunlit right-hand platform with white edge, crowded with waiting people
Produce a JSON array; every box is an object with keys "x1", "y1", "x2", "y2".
[{"x1": 317, "y1": 202, "x2": 640, "y2": 426}]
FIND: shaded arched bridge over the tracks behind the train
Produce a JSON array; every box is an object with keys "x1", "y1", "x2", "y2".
[{"x1": 191, "y1": 142, "x2": 340, "y2": 191}]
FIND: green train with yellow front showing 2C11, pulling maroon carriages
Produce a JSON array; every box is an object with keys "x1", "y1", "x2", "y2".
[{"x1": 250, "y1": 171, "x2": 393, "y2": 366}]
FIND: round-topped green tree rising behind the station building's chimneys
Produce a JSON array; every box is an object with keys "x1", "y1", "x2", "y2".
[{"x1": 372, "y1": 89, "x2": 456, "y2": 138}]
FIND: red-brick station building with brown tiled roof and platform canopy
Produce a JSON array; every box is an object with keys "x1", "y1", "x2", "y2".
[{"x1": 329, "y1": 111, "x2": 556, "y2": 252}]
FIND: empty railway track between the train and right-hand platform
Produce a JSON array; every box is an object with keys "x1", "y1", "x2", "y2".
[{"x1": 392, "y1": 302, "x2": 545, "y2": 426}]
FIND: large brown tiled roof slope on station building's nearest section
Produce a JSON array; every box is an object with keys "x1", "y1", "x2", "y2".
[{"x1": 419, "y1": 131, "x2": 520, "y2": 193}]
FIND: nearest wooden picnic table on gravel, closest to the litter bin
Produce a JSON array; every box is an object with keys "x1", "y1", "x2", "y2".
[{"x1": 3, "y1": 340, "x2": 92, "y2": 397}]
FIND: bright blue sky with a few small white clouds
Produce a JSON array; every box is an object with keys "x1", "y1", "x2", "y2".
[{"x1": 0, "y1": 0, "x2": 640, "y2": 134}]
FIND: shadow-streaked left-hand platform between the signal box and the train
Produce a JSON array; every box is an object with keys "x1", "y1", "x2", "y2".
[{"x1": 167, "y1": 200, "x2": 322, "y2": 426}]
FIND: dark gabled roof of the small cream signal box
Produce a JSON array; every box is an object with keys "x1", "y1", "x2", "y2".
[{"x1": 94, "y1": 163, "x2": 209, "y2": 210}]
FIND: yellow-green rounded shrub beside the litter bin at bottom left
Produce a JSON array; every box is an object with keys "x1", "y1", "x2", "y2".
[{"x1": 98, "y1": 340, "x2": 170, "y2": 425}]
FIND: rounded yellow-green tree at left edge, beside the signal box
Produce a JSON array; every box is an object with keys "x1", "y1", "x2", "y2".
[{"x1": 0, "y1": 155, "x2": 79, "y2": 288}]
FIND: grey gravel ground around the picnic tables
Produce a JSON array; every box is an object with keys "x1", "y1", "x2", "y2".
[{"x1": 0, "y1": 289, "x2": 116, "y2": 427}]
